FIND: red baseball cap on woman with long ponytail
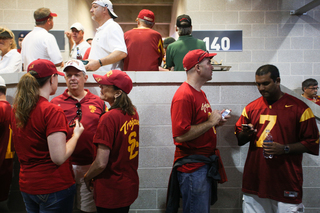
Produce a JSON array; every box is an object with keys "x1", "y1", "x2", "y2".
[{"x1": 28, "y1": 59, "x2": 64, "y2": 78}]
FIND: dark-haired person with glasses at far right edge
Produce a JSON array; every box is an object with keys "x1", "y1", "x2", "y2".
[{"x1": 301, "y1": 78, "x2": 320, "y2": 105}]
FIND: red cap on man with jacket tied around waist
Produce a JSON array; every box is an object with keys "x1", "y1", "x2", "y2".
[{"x1": 182, "y1": 49, "x2": 217, "y2": 71}]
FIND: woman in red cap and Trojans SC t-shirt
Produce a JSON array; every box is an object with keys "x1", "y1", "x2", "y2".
[{"x1": 84, "y1": 70, "x2": 139, "y2": 213}]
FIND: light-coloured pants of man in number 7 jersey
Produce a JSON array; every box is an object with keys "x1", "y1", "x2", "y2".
[{"x1": 242, "y1": 193, "x2": 304, "y2": 213}]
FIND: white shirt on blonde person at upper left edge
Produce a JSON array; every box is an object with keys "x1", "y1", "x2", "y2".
[{"x1": 0, "y1": 49, "x2": 22, "y2": 74}]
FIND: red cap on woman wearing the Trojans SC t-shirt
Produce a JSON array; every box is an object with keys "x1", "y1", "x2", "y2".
[{"x1": 92, "y1": 70, "x2": 132, "y2": 94}]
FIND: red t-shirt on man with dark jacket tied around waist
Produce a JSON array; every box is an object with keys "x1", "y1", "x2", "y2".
[{"x1": 171, "y1": 82, "x2": 216, "y2": 172}]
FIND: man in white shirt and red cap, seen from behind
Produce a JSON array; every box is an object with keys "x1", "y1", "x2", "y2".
[{"x1": 21, "y1": 7, "x2": 63, "y2": 71}]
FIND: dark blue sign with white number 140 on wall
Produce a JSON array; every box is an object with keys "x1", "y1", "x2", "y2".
[{"x1": 192, "y1": 30, "x2": 242, "y2": 52}]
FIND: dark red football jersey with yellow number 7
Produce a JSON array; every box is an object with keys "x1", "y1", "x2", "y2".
[{"x1": 235, "y1": 94, "x2": 319, "y2": 204}]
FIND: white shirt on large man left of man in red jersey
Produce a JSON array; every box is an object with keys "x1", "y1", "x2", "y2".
[{"x1": 89, "y1": 18, "x2": 127, "y2": 72}]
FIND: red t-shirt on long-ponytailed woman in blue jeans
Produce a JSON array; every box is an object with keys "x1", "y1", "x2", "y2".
[{"x1": 11, "y1": 96, "x2": 75, "y2": 195}]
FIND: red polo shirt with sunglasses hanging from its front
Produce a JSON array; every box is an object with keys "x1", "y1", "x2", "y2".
[{"x1": 51, "y1": 89, "x2": 106, "y2": 165}]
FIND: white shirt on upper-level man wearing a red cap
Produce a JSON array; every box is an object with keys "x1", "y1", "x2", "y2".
[{"x1": 21, "y1": 27, "x2": 62, "y2": 71}]
